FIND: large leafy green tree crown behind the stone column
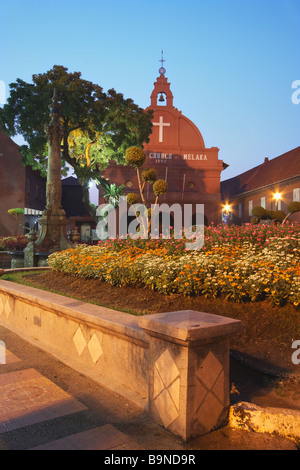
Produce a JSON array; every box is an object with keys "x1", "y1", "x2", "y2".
[{"x1": 0, "y1": 65, "x2": 153, "y2": 217}]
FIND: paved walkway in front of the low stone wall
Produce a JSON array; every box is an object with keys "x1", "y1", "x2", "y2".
[{"x1": 0, "y1": 327, "x2": 296, "y2": 453}]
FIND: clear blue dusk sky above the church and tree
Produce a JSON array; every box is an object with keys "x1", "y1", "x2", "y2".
[{"x1": 0, "y1": 0, "x2": 300, "y2": 188}]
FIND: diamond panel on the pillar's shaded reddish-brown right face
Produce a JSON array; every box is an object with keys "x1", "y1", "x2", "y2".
[{"x1": 195, "y1": 351, "x2": 224, "y2": 430}]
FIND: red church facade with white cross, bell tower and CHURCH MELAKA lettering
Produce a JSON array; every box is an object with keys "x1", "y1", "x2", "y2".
[{"x1": 99, "y1": 60, "x2": 228, "y2": 225}]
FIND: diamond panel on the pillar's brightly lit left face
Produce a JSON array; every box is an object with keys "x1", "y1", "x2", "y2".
[{"x1": 153, "y1": 349, "x2": 180, "y2": 428}]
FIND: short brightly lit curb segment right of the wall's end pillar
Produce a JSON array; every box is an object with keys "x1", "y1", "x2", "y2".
[{"x1": 228, "y1": 402, "x2": 300, "y2": 442}]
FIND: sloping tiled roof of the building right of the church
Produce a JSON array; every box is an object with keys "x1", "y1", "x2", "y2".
[{"x1": 221, "y1": 147, "x2": 300, "y2": 199}]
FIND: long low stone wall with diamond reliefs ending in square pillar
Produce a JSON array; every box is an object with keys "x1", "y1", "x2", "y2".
[{"x1": 0, "y1": 280, "x2": 241, "y2": 440}]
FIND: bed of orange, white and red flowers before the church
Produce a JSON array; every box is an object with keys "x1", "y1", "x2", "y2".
[{"x1": 48, "y1": 224, "x2": 300, "y2": 307}]
